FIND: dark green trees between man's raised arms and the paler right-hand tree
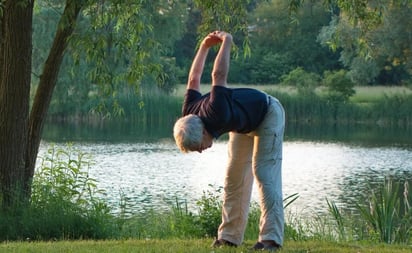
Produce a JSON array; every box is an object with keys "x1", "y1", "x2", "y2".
[{"x1": 240, "y1": 0, "x2": 339, "y2": 84}]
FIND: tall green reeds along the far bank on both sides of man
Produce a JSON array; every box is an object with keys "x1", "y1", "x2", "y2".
[{"x1": 46, "y1": 86, "x2": 412, "y2": 130}]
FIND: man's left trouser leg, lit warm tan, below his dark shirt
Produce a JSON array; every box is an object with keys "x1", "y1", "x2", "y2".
[{"x1": 218, "y1": 132, "x2": 253, "y2": 245}]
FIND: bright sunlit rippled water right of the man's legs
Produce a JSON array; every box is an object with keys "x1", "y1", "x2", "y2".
[{"x1": 284, "y1": 142, "x2": 412, "y2": 212}]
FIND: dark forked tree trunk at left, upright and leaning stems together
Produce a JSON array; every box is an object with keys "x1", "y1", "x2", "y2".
[{"x1": 0, "y1": 0, "x2": 82, "y2": 208}]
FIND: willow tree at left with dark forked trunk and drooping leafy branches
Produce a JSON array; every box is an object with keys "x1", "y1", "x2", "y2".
[{"x1": 0, "y1": 0, "x2": 264, "y2": 209}]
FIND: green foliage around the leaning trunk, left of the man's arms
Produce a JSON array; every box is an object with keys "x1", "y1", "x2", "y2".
[{"x1": 33, "y1": 0, "x2": 187, "y2": 116}]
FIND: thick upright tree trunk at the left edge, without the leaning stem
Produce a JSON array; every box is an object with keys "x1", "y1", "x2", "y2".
[{"x1": 0, "y1": 0, "x2": 33, "y2": 207}]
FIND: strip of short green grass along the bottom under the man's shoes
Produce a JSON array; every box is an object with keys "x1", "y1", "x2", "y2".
[{"x1": 0, "y1": 239, "x2": 412, "y2": 253}]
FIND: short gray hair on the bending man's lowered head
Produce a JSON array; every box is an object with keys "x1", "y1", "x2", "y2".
[{"x1": 173, "y1": 114, "x2": 204, "y2": 153}]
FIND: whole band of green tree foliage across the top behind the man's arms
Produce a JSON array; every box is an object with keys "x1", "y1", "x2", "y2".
[{"x1": 33, "y1": 0, "x2": 412, "y2": 117}]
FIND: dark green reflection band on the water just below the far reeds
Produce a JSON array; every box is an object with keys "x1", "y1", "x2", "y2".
[{"x1": 43, "y1": 120, "x2": 412, "y2": 147}]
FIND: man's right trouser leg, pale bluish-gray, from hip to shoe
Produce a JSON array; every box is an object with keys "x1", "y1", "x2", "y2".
[{"x1": 253, "y1": 99, "x2": 285, "y2": 246}]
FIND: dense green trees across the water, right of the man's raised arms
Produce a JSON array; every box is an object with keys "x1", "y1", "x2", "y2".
[{"x1": 174, "y1": 0, "x2": 412, "y2": 85}]
